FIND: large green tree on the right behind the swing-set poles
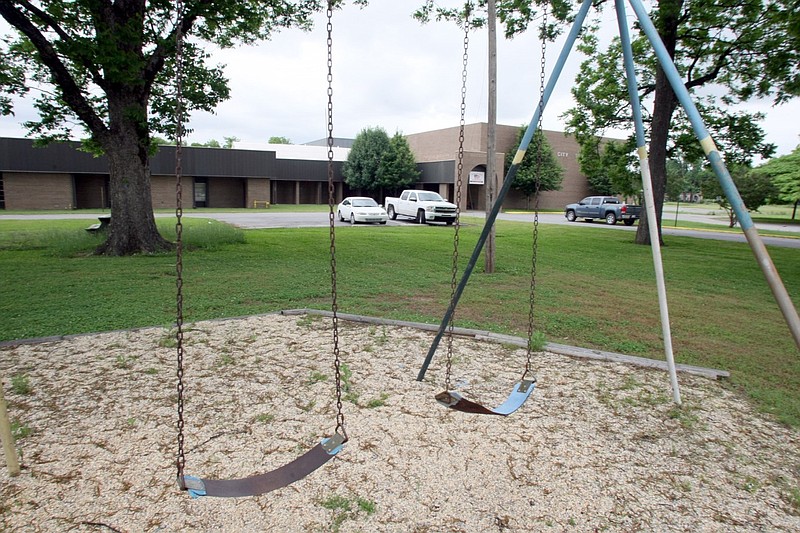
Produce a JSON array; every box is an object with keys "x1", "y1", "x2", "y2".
[{"x1": 567, "y1": 0, "x2": 800, "y2": 243}]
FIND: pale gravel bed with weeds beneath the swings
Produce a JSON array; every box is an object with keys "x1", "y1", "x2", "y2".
[{"x1": 0, "y1": 315, "x2": 800, "y2": 532}]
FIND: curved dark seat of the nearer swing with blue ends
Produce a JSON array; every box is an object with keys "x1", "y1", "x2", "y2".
[{"x1": 183, "y1": 433, "x2": 347, "y2": 498}]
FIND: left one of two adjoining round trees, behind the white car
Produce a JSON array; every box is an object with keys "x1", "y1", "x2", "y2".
[{"x1": 342, "y1": 127, "x2": 391, "y2": 193}]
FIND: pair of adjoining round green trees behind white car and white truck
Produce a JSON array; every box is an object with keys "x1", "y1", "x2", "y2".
[{"x1": 342, "y1": 127, "x2": 419, "y2": 193}]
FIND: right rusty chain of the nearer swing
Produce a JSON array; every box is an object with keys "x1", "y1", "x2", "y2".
[{"x1": 327, "y1": 0, "x2": 347, "y2": 442}]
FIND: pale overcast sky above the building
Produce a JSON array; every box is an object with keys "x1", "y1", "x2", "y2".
[{"x1": 0, "y1": 0, "x2": 800, "y2": 159}]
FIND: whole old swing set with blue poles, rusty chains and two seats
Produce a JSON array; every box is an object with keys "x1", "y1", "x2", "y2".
[{"x1": 164, "y1": 0, "x2": 800, "y2": 497}]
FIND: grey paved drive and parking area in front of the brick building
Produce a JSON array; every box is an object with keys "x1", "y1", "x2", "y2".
[{"x1": 0, "y1": 211, "x2": 800, "y2": 249}]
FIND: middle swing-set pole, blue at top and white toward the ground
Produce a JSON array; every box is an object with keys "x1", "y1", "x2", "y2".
[{"x1": 614, "y1": 0, "x2": 681, "y2": 405}]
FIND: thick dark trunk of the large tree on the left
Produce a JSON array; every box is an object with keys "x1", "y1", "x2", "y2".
[{"x1": 96, "y1": 94, "x2": 172, "y2": 255}]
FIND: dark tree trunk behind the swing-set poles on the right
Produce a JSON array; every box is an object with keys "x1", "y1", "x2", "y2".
[{"x1": 635, "y1": 0, "x2": 683, "y2": 245}]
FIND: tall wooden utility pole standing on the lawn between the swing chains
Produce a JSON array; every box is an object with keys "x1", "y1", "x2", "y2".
[{"x1": 483, "y1": 0, "x2": 498, "y2": 274}]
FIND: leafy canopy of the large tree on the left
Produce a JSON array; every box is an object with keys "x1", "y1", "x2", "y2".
[{"x1": 0, "y1": 0, "x2": 340, "y2": 144}]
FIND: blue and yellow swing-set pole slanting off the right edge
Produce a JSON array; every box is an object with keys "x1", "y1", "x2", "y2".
[{"x1": 629, "y1": 0, "x2": 800, "y2": 349}]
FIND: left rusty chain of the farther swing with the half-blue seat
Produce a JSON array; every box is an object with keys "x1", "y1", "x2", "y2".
[{"x1": 444, "y1": 2, "x2": 471, "y2": 390}]
